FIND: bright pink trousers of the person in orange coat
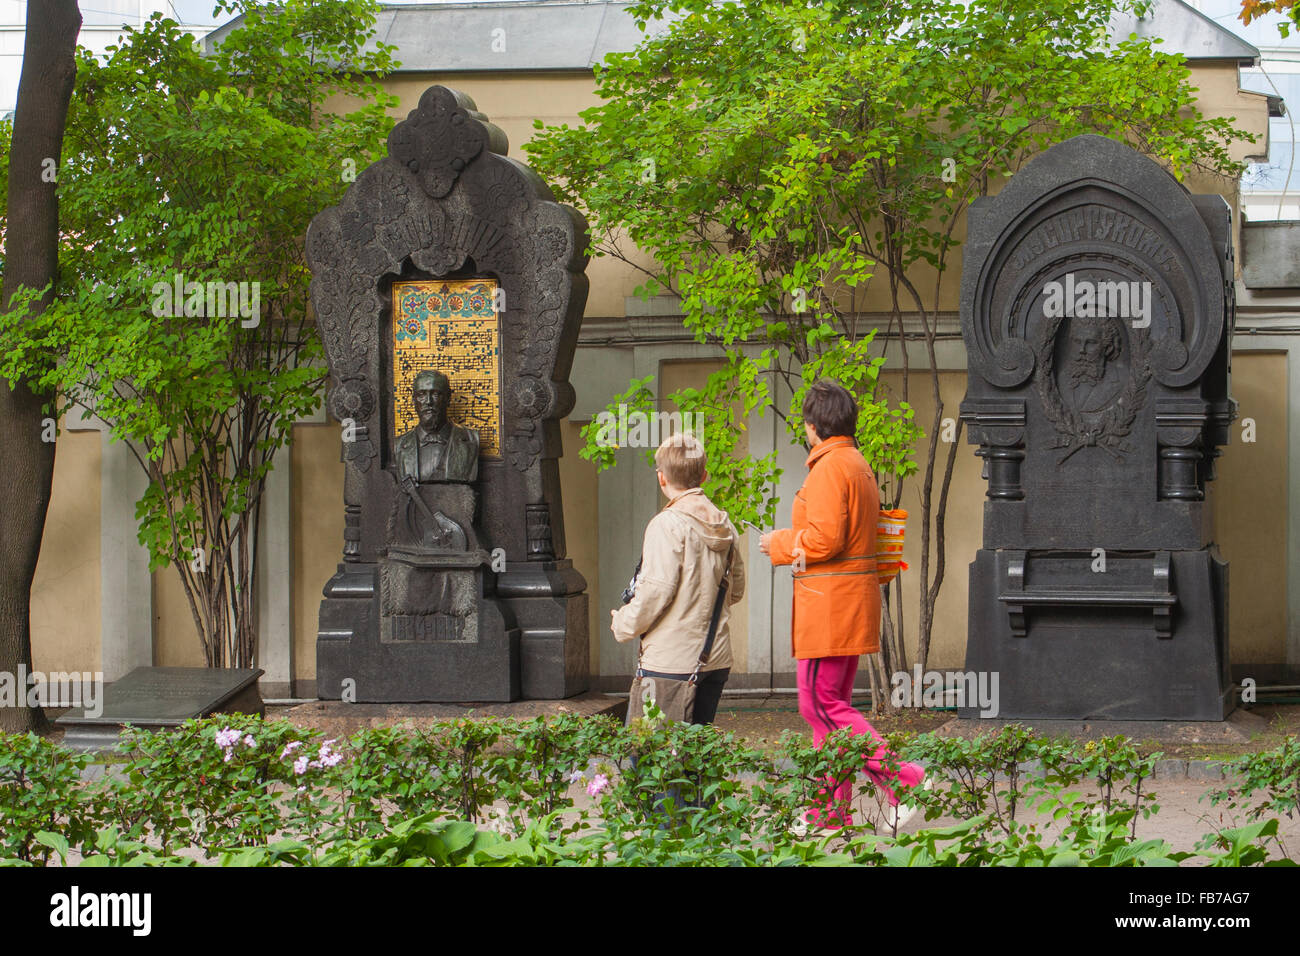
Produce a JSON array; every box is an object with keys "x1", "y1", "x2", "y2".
[{"x1": 797, "y1": 657, "x2": 926, "y2": 826}]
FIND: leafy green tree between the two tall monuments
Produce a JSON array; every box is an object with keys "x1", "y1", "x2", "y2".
[{"x1": 528, "y1": 0, "x2": 1242, "y2": 700}]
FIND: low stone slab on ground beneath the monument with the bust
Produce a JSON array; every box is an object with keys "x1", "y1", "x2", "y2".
[{"x1": 280, "y1": 692, "x2": 628, "y2": 736}]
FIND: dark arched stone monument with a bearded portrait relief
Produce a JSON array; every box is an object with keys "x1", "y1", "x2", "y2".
[{"x1": 961, "y1": 135, "x2": 1236, "y2": 721}]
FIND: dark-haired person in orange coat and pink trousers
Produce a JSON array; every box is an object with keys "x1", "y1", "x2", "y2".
[{"x1": 759, "y1": 380, "x2": 926, "y2": 826}]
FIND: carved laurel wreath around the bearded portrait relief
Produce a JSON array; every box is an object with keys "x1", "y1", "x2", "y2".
[{"x1": 1034, "y1": 316, "x2": 1151, "y2": 467}]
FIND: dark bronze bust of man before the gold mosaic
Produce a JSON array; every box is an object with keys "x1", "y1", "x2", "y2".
[{"x1": 393, "y1": 371, "x2": 478, "y2": 484}]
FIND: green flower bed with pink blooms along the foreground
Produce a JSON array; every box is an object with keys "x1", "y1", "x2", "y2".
[{"x1": 0, "y1": 715, "x2": 1300, "y2": 865}]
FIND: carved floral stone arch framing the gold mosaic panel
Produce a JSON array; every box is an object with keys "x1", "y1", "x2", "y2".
[{"x1": 307, "y1": 87, "x2": 588, "y2": 550}]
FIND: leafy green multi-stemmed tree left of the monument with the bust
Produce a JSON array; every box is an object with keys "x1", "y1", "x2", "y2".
[{"x1": 0, "y1": 0, "x2": 397, "y2": 666}]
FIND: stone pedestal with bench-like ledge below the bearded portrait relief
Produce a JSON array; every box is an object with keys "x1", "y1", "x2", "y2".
[{"x1": 962, "y1": 549, "x2": 1234, "y2": 721}]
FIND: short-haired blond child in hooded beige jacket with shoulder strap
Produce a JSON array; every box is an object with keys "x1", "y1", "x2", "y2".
[{"x1": 611, "y1": 433, "x2": 745, "y2": 723}]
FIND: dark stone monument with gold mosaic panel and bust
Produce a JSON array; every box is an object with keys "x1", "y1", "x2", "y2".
[{"x1": 307, "y1": 86, "x2": 589, "y2": 702}]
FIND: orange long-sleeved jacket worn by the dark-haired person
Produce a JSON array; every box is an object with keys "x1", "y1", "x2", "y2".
[{"x1": 768, "y1": 436, "x2": 880, "y2": 661}]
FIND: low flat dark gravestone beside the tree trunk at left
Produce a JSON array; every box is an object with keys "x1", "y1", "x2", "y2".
[{"x1": 55, "y1": 667, "x2": 267, "y2": 752}]
